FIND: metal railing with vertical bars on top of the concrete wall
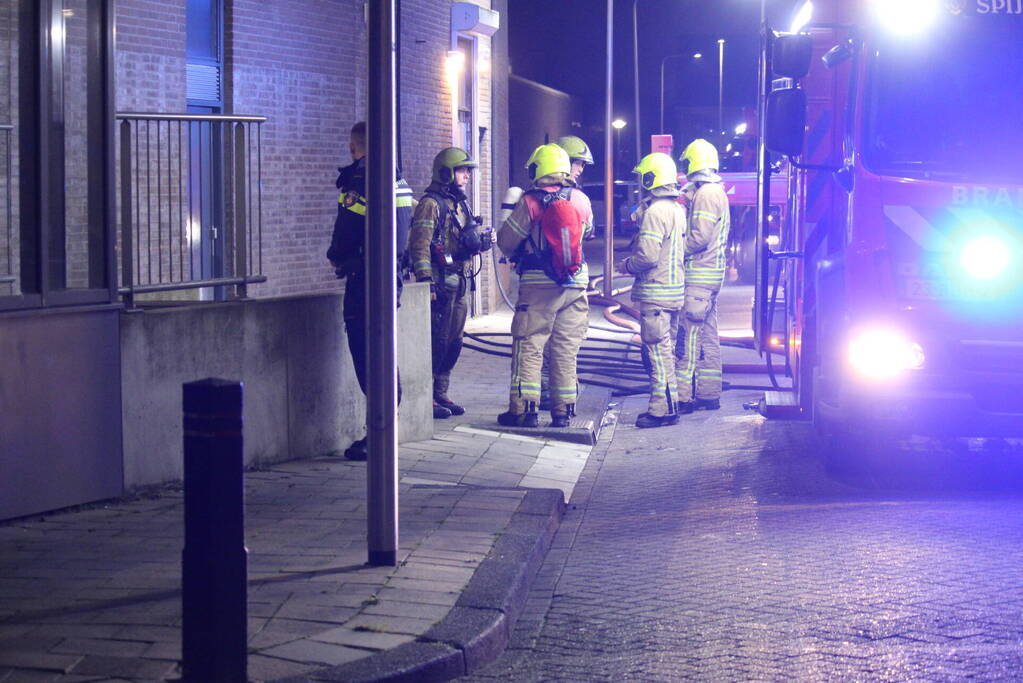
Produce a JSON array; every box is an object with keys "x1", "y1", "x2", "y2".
[{"x1": 117, "y1": 113, "x2": 266, "y2": 308}]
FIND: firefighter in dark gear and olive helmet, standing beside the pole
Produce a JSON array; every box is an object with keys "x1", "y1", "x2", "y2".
[{"x1": 408, "y1": 147, "x2": 491, "y2": 419}]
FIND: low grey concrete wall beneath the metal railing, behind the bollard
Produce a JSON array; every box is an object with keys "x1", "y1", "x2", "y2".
[{"x1": 121, "y1": 284, "x2": 433, "y2": 489}]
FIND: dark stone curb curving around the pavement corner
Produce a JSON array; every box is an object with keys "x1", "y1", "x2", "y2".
[{"x1": 277, "y1": 489, "x2": 565, "y2": 683}]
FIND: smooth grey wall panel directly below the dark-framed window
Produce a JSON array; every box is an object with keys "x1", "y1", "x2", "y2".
[{"x1": 0, "y1": 308, "x2": 121, "y2": 519}]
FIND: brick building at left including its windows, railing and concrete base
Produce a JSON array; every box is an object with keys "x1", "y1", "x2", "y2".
[{"x1": 0, "y1": 0, "x2": 508, "y2": 518}]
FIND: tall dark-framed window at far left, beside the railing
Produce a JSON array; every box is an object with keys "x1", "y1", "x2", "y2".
[{"x1": 0, "y1": 0, "x2": 116, "y2": 308}]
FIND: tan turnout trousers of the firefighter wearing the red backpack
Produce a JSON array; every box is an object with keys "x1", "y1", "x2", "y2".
[{"x1": 508, "y1": 284, "x2": 589, "y2": 415}]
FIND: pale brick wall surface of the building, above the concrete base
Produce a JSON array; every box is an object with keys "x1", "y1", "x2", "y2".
[{"x1": 117, "y1": 0, "x2": 507, "y2": 311}]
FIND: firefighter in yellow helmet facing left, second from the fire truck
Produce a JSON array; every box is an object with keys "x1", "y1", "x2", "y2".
[{"x1": 618, "y1": 152, "x2": 686, "y2": 428}]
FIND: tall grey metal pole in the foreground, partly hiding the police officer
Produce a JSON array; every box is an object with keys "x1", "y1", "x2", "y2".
[{"x1": 365, "y1": 0, "x2": 398, "y2": 566}]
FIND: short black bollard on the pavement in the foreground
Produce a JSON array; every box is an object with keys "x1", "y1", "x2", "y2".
[{"x1": 181, "y1": 378, "x2": 249, "y2": 683}]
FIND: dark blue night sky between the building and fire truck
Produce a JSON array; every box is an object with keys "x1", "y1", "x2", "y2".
[{"x1": 507, "y1": 0, "x2": 796, "y2": 156}]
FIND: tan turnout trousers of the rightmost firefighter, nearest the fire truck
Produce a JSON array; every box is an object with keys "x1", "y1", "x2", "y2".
[{"x1": 675, "y1": 285, "x2": 721, "y2": 402}]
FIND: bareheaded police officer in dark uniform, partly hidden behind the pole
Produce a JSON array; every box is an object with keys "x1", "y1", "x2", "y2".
[{"x1": 326, "y1": 121, "x2": 412, "y2": 460}]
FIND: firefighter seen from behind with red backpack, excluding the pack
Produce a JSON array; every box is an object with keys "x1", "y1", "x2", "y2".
[{"x1": 497, "y1": 144, "x2": 593, "y2": 427}]
